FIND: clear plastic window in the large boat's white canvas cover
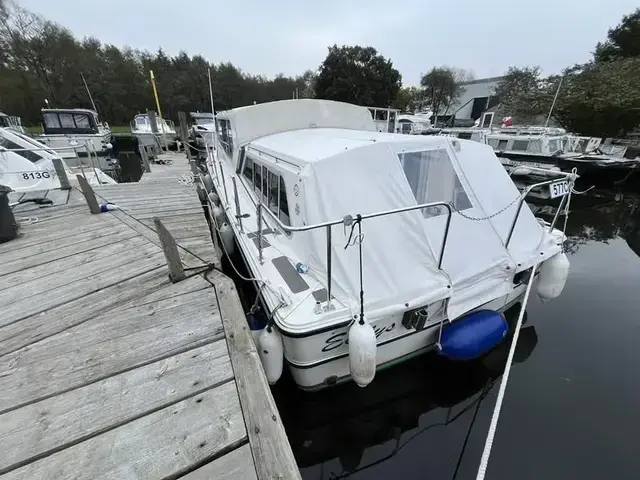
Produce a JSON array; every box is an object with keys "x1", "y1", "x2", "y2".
[{"x1": 398, "y1": 149, "x2": 472, "y2": 218}]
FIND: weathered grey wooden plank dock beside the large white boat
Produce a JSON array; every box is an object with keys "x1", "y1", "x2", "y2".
[{"x1": 0, "y1": 154, "x2": 300, "y2": 480}]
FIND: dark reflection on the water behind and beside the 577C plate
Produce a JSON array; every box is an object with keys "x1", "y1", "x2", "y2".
[{"x1": 528, "y1": 190, "x2": 640, "y2": 256}]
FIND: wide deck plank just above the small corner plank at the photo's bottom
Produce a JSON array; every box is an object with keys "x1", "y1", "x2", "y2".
[{"x1": 3, "y1": 382, "x2": 246, "y2": 480}]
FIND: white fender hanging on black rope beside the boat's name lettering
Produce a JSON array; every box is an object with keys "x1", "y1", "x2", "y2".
[{"x1": 349, "y1": 319, "x2": 377, "y2": 387}]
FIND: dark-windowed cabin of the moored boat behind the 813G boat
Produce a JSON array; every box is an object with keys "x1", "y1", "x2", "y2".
[{"x1": 42, "y1": 108, "x2": 108, "y2": 135}]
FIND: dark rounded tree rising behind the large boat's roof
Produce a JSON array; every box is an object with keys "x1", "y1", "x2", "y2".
[{"x1": 315, "y1": 45, "x2": 402, "y2": 107}]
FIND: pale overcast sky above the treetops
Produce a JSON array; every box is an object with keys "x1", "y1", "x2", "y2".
[{"x1": 18, "y1": 0, "x2": 638, "y2": 84}]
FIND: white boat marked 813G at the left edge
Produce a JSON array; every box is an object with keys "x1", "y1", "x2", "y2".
[{"x1": 0, "y1": 128, "x2": 117, "y2": 192}]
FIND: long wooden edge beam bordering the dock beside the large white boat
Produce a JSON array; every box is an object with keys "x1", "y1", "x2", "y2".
[{"x1": 209, "y1": 270, "x2": 302, "y2": 480}]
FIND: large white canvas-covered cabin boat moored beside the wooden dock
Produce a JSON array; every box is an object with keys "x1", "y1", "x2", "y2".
[{"x1": 205, "y1": 99, "x2": 568, "y2": 389}]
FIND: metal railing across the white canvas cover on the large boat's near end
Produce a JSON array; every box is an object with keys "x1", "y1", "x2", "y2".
[{"x1": 255, "y1": 199, "x2": 453, "y2": 309}]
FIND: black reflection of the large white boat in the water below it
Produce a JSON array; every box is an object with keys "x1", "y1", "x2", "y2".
[{"x1": 273, "y1": 304, "x2": 538, "y2": 480}]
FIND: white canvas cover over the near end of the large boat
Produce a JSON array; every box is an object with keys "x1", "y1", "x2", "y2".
[{"x1": 252, "y1": 128, "x2": 560, "y2": 320}]
